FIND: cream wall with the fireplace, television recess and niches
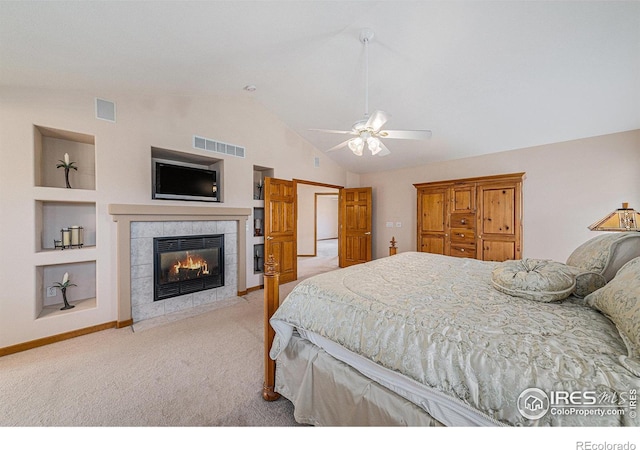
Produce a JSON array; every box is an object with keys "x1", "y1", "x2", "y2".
[{"x1": 0, "y1": 87, "x2": 350, "y2": 348}]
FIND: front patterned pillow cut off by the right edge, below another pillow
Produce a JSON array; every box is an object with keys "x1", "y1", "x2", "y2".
[{"x1": 584, "y1": 257, "x2": 640, "y2": 364}]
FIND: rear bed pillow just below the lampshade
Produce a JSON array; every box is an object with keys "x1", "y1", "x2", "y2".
[{"x1": 567, "y1": 231, "x2": 640, "y2": 281}]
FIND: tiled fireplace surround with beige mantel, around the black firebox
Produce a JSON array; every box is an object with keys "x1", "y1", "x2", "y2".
[{"x1": 109, "y1": 204, "x2": 251, "y2": 327}]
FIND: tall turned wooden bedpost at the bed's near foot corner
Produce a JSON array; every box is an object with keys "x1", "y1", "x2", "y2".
[{"x1": 262, "y1": 255, "x2": 280, "y2": 402}]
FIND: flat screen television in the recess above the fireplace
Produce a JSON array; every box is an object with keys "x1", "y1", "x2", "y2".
[{"x1": 152, "y1": 159, "x2": 218, "y2": 202}]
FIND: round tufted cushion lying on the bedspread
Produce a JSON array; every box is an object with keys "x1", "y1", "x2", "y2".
[{"x1": 491, "y1": 259, "x2": 582, "y2": 302}]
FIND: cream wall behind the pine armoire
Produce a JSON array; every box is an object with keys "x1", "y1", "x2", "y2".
[{"x1": 360, "y1": 130, "x2": 640, "y2": 262}]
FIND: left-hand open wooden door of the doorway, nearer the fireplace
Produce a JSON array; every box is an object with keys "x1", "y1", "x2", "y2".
[{"x1": 264, "y1": 177, "x2": 298, "y2": 283}]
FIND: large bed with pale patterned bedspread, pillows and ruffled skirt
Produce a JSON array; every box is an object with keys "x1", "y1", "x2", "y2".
[{"x1": 263, "y1": 232, "x2": 640, "y2": 426}]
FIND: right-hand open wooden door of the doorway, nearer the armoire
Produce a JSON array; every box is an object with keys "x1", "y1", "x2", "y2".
[{"x1": 338, "y1": 187, "x2": 372, "y2": 267}]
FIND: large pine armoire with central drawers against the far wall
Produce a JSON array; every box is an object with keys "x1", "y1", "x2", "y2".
[{"x1": 414, "y1": 173, "x2": 524, "y2": 261}]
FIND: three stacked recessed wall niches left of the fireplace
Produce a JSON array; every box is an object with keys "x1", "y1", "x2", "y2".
[{"x1": 33, "y1": 125, "x2": 97, "y2": 324}]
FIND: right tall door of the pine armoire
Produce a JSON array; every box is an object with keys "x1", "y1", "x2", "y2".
[{"x1": 477, "y1": 183, "x2": 522, "y2": 261}]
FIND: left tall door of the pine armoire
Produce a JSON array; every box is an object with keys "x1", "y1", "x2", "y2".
[{"x1": 418, "y1": 187, "x2": 449, "y2": 255}]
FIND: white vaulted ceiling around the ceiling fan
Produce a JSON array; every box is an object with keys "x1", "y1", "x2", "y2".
[{"x1": 0, "y1": 0, "x2": 640, "y2": 173}]
